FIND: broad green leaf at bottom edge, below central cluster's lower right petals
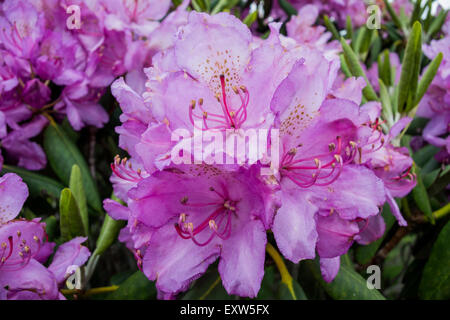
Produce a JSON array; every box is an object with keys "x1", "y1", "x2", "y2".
[{"x1": 305, "y1": 260, "x2": 385, "y2": 300}]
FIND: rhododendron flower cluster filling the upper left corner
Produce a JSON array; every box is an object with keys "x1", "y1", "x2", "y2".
[{"x1": 0, "y1": 0, "x2": 187, "y2": 170}]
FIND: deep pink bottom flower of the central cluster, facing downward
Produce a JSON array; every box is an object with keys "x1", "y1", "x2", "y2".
[{"x1": 105, "y1": 165, "x2": 276, "y2": 297}]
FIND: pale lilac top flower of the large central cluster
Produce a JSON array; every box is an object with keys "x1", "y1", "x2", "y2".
[{"x1": 135, "y1": 12, "x2": 300, "y2": 172}]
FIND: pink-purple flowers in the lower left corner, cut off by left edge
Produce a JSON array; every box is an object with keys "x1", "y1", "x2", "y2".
[{"x1": 0, "y1": 173, "x2": 90, "y2": 300}]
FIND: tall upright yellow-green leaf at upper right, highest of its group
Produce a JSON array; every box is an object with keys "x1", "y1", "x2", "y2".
[{"x1": 397, "y1": 22, "x2": 422, "y2": 112}]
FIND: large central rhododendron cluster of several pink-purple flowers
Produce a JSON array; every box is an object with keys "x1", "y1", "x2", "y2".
[{"x1": 105, "y1": 8, "x2": 415, "y2": 298}]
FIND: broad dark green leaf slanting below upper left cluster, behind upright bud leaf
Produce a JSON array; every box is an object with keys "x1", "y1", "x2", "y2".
[{"x1": 44, "y1": 122, "x2": 102, "y2": 212}]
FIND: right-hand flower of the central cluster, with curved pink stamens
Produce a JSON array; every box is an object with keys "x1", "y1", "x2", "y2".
[{"x1": 271, "y1": 47, "x2": 414, "y2": 281}]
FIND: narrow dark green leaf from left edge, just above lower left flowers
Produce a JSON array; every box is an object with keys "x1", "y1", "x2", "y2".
[{"x1": 2, "y1": 165, "x2": 64, "y2": 199}]
